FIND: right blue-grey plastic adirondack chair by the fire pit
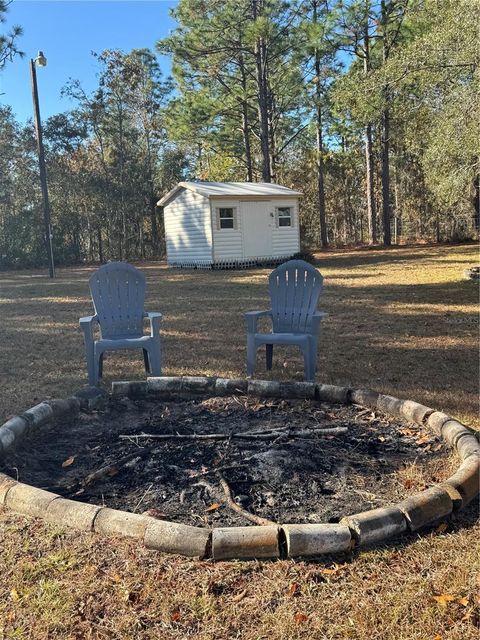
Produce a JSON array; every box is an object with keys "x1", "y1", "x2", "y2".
[{"x1": 245, "y1": 260, "x2": 328, "y2": 381}]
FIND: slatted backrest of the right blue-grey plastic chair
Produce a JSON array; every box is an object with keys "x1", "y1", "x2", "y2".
[{"x1": 268, "y1": 260, "x2": 323, "y2": 333}]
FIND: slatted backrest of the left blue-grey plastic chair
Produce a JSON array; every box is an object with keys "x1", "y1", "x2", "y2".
[{"x1": 88, "y1": 262, "x2": 145, "y2": 339}]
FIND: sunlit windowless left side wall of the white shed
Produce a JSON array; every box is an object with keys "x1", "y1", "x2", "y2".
[{"x1": 164, "y1": 189, "x2": 212, "y2": 263}]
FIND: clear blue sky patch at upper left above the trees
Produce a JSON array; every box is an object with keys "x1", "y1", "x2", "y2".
[{"x1": 0, "y1": 0, "x2": 176, "y2": 121}]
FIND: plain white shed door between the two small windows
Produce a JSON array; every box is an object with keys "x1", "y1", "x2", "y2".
[{"x1": 241, "y1": 201, "x2": 275, "y2": 258}]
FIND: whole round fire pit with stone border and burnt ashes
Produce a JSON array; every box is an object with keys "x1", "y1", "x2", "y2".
[{"x1": 0, "y1": 377, "x2": 480, "y2": 559}]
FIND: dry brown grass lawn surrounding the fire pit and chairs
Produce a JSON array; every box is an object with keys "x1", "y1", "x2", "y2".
[{"x1": 0, "y1": 245, "x2": 480, "y2": 640}]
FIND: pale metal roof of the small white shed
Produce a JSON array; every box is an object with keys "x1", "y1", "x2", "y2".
[{"x1": 157, "y1": 182, "x2": 302, "y2": 207}]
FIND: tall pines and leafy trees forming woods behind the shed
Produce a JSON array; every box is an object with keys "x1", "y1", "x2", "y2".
[{"x1": 0, "y1": 0, "x2": 480, "y2": 266}]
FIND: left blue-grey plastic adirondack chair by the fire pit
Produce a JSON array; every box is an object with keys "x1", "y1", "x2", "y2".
[{"x1": 80, "y1": 262, "x2": 162, "y2": 385}]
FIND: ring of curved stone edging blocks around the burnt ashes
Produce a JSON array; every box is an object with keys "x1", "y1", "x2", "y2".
[{"x1": 0, "y1": 376, "x2": 480, "y2": 560}]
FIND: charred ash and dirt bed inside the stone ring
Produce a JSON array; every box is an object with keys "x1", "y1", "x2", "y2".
[{"x1": 0, "y1": 397, "x2": 454, "y2": 527}]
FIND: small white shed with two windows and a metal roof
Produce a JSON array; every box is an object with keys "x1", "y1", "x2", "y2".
[{"x1": 158, "y1": 182, "x2": 301, "y2": 269}]
